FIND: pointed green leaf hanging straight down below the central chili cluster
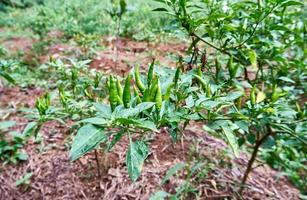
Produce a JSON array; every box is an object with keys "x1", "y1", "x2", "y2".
[{"x1": 126, "y1": 141, "x2": 149, "y2": 182}]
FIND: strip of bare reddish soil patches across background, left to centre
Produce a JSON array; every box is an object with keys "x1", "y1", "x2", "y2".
[{"x1": 2, "y1": 32, "x2": 187, "y2": 75}]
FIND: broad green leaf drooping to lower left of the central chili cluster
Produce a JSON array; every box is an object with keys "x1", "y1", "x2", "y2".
[{"x1": 69, "y1": 124, "x2": 107, "y2": 161}]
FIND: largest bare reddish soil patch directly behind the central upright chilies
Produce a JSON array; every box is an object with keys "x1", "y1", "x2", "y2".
[{"x1": 91, "y1": 38, "x2": 186, "y2": 75}]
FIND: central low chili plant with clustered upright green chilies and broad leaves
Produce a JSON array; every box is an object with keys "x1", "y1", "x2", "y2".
[{"x1": 70, "y1": 62, "x2": 194, "y2": 181}]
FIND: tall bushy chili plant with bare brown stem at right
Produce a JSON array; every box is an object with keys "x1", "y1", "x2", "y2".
[{"x1": 154, "y1": 0, "x2": 306, "y2": 193}]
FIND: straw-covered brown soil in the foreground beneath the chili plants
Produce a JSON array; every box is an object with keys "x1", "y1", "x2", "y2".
[{"x1": 0, "y1": 98, "x2": 299, "y2": 200}]
